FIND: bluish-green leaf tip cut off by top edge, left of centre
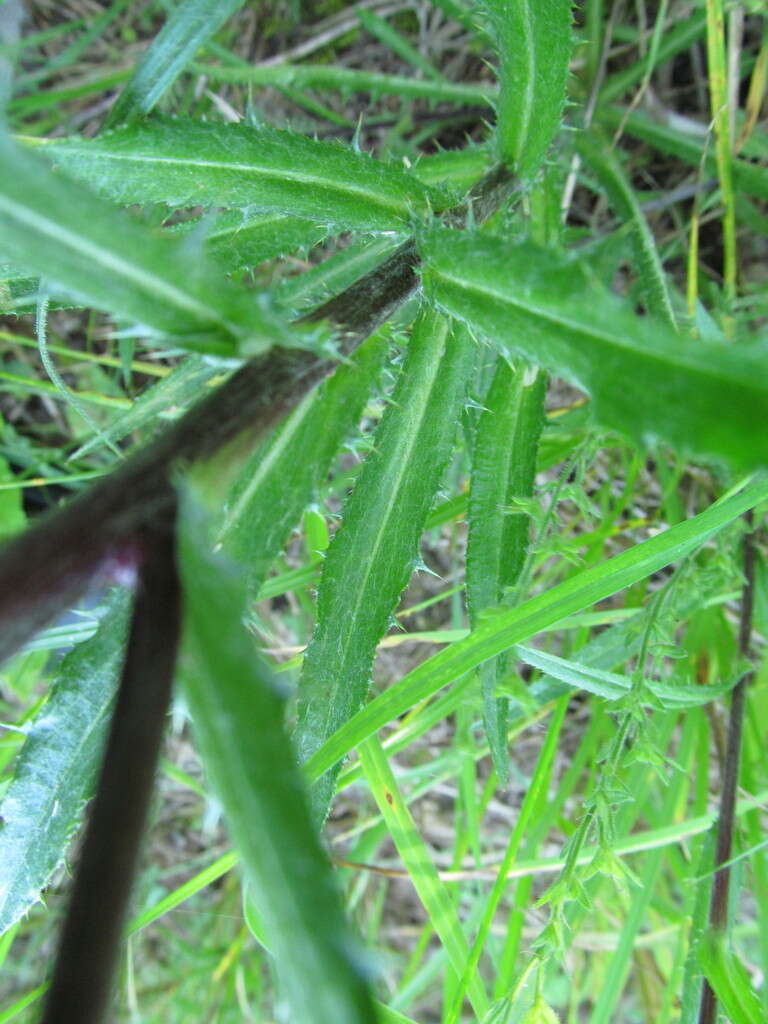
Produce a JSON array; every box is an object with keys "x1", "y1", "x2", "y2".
[{"x1": 106, "y1": 0, "x2": 243, "y2": 125}]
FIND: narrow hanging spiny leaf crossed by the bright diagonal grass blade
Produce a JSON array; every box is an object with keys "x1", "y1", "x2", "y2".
[{"x1": 467, "y1": 356, "x2": 546, "y2": 783}]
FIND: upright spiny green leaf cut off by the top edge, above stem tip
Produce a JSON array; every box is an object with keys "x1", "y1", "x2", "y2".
[{"x1": 480, "y1": 0, "x2": 572, "y2": 181}]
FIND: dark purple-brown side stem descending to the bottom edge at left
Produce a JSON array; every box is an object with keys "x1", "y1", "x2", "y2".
[{"x1": 42, "y1": 486, "x2": 181, "y2": 1024}]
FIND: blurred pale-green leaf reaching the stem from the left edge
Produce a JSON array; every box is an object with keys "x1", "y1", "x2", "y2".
[{"x1": 0, "y1": 132, "x2": 296, "y2": 356}]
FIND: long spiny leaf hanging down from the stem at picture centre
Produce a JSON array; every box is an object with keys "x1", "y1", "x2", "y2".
[{"x1": 295, "y1": 310, "x2": 475, "y2": 820}]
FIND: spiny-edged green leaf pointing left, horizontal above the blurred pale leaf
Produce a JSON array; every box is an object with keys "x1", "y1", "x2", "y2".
[{"x1": 37, "y1": 118, "x2": 446, "y2": 231}]
